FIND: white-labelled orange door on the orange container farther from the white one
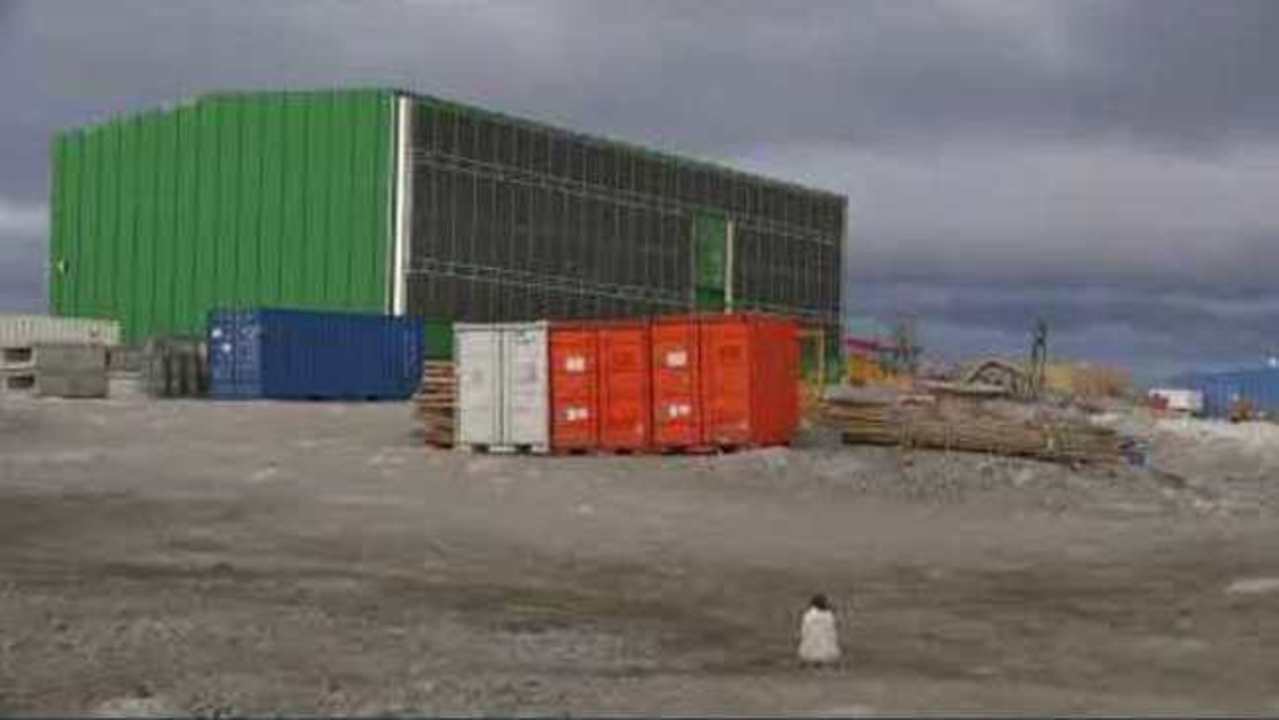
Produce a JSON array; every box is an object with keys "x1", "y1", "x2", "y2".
[{"x1": 651, "y1": 321, "x2": 701, "y2": 448}]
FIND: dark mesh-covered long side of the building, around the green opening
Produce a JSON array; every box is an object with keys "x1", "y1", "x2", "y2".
[{"x1": 407, "y1": 100, "x2": 845, "y2": 325}]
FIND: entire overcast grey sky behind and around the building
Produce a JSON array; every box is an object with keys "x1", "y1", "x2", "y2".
[{"x1": 0, "y1": 0, "x2": 1279, "y2": 376}]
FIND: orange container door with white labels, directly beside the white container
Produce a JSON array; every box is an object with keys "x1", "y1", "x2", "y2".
[{"x1": 550, "y1": 326, "x2": 600, "y2": 450}]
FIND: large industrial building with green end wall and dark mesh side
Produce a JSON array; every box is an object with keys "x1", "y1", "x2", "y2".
[{"x1": 49, "y1": 90, "x2": 847, "y2": 352}]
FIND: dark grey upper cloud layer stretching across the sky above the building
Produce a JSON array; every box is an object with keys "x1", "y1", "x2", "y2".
[{"x1": 9, "y1": 0, "x2": 1279, "y2": 163}]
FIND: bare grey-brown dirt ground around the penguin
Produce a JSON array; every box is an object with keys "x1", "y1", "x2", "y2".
[{"x1": 0, "y1": 400, "x2": 1279, "y2": 715}]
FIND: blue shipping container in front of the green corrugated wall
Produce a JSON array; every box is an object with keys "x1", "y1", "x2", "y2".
[{"x1": 208, "y1": 309, "x2": 423, "y2": 400}]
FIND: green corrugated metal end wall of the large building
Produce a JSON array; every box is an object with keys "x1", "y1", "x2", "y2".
[{"x1": 49, "y1": 91, "x2": 394, "y2": 340}]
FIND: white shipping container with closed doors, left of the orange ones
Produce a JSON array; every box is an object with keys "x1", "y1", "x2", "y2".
[{"x1": 453, "y1": 322, "x2": 550, "y2": 450}]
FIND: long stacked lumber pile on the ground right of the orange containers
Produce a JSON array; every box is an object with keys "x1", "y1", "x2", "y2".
[{"x1": 825, "y1": 400, "x2": 1122, "y2": 463}]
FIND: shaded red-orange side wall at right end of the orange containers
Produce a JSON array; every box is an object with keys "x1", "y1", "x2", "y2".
[{"x1": 751, "y1": 320, "x2": 799, "y2": 445}]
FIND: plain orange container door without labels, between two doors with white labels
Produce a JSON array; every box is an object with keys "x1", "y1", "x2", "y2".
[{"x1": 600, "y1": 326, "x2": 652, "y2": 450}]
